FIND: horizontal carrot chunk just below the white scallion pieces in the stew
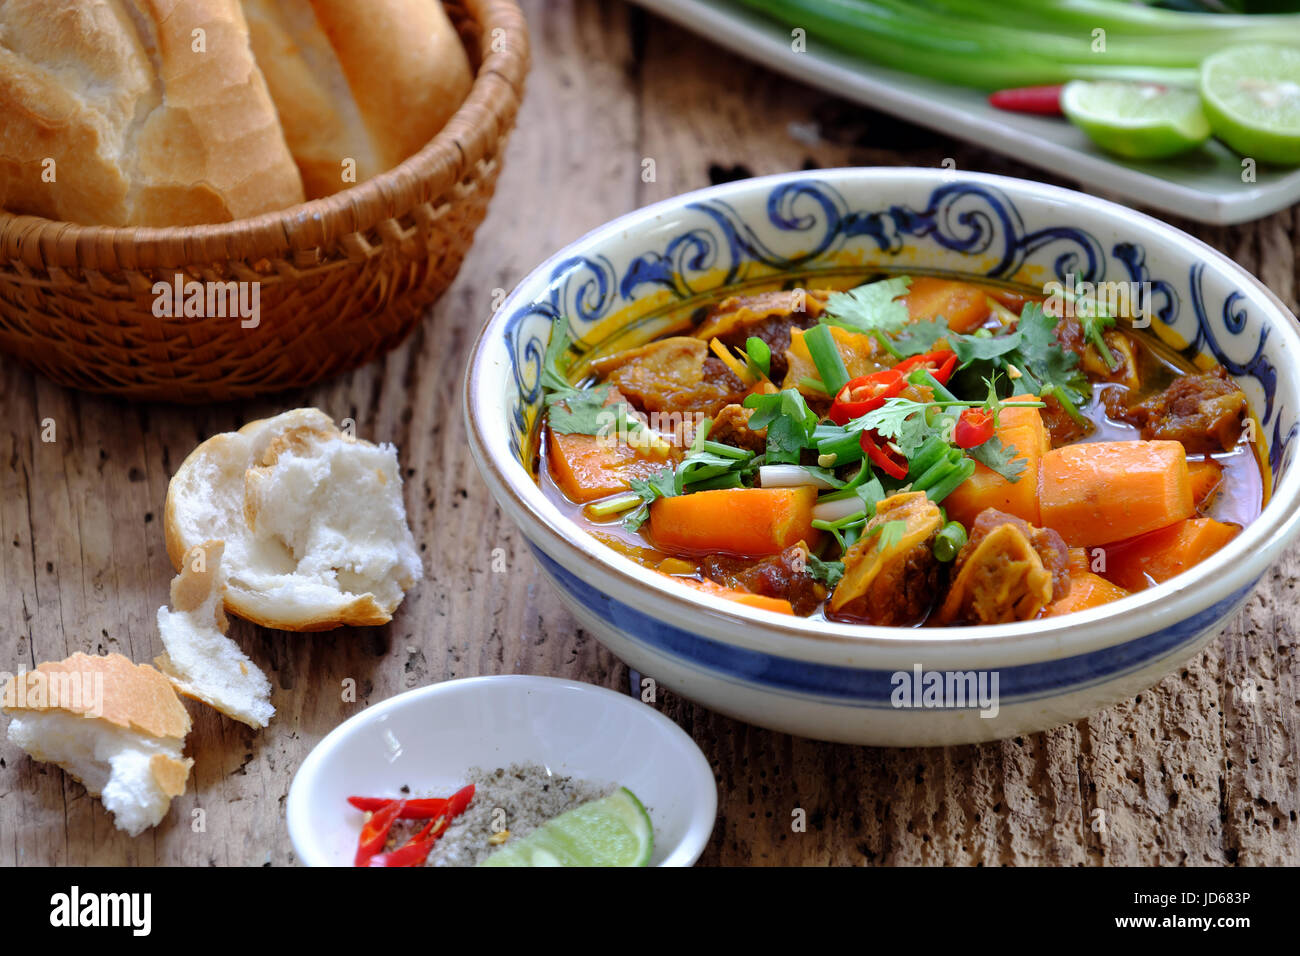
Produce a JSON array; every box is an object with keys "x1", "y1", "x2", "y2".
[{"x1": 649, "y1": 485, "x2": 816, "y2": 557}]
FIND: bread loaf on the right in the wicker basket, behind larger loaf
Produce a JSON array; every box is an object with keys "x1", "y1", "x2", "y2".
[{"x1": 243, "y1": 0, "x2": 473, "y2": 198}]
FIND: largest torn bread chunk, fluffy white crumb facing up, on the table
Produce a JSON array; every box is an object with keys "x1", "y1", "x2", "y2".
[{"x1": 165, "y1": 408, "x2": 424, "y2": 631}]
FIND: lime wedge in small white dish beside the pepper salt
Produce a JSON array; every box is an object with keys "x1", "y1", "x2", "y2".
[{"x1": 480, "y1": 787, "x2": 654, "y2": 866}]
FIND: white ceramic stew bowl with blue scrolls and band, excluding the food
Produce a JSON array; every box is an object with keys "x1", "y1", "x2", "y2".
[{"x1": 465, "y1": 169, "x2": 1300, "y2": 745}]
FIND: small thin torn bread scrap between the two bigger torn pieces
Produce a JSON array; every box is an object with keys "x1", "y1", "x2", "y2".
[{"x1": 153, "y1": 541, "x2": 276, "y2": 727}]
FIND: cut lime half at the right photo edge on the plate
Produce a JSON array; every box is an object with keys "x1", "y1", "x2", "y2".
[{"x1": 1201, "y1": 46, "x2": 1300, "y2": 165}]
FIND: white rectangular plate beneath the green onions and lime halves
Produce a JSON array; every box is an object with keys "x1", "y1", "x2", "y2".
[{"x1": 636, "y1": 0, "x2": 1300, "y2": 225}]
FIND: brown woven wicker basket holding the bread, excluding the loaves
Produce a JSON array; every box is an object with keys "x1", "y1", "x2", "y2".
[{"x1": 0, "y1": 0, "x2": 528, "y2": 402}]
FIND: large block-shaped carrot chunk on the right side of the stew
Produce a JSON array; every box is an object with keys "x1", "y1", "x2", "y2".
[{"x1": 1039, "y1": 441, "x2": 1196, "y2": 546}]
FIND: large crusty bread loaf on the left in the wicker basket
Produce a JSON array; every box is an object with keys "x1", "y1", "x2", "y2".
[{"x1": 0, "y1": 0, "x2": 303, "y2": 226}]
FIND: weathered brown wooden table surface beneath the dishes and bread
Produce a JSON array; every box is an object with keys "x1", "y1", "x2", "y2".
[{"x1": 0, "y1": 0, "x2": 1300, "y2": 865}]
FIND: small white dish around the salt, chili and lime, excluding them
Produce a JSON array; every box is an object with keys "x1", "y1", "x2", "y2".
[{"x1": 287, "y1": 675, "x2": 718, "y2": 866}]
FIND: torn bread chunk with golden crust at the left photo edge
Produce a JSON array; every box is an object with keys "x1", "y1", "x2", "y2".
[{"x1": 0, "y1": 654, "x2": 194, "y2": 836}]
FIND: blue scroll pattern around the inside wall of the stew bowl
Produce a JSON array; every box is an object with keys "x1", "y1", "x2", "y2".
[{"x1": 507, "y1": 176, "x2": 1297, "y2": 473}]
